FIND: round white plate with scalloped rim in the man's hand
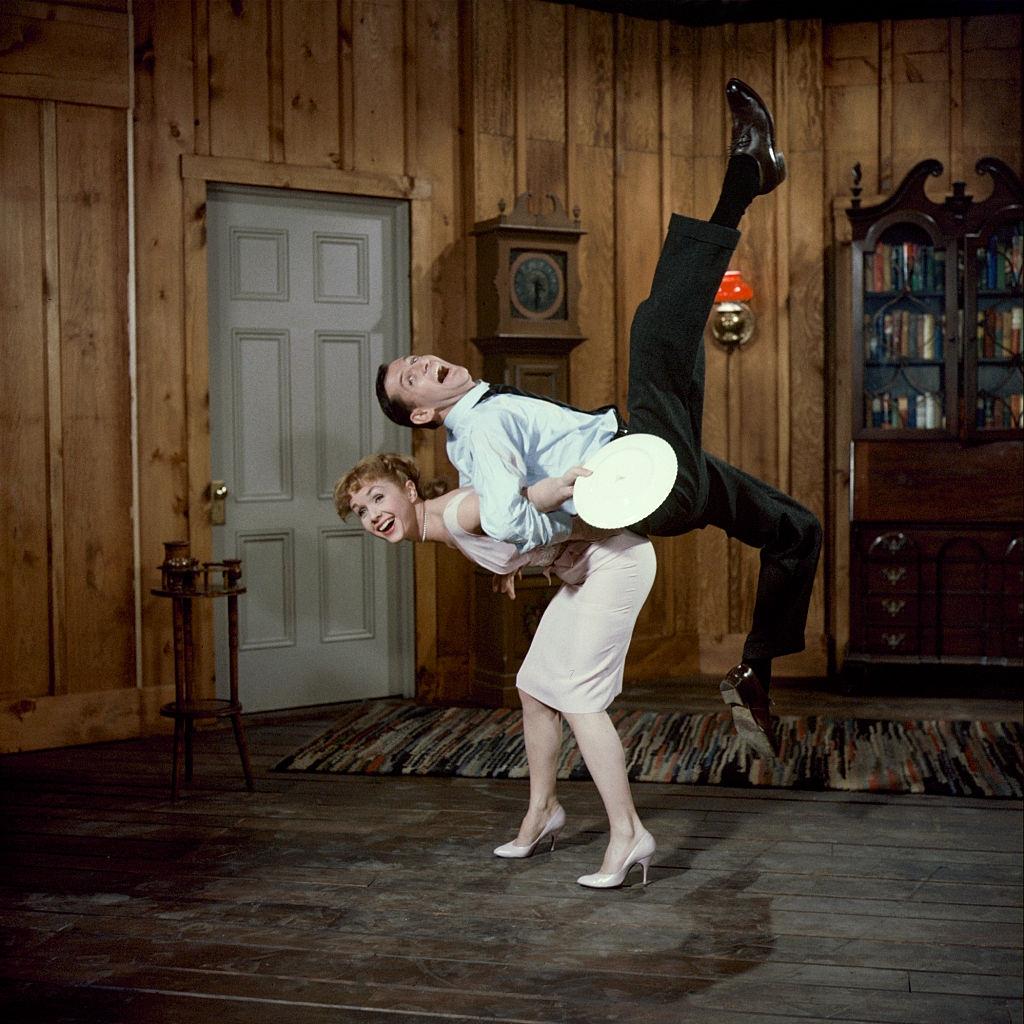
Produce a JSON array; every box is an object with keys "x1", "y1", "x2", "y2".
[{"x1": 572, "y1": 434, "x2": 677, "y2": 529}]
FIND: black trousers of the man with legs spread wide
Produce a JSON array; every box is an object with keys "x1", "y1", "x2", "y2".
[{"x1": 628, "y1": 214, "x2": 821, "y2": 659}]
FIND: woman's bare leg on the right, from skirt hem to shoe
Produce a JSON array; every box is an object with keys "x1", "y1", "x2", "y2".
[{"x1": 565, "y1": 711, "x2": 643, "y2": 871}]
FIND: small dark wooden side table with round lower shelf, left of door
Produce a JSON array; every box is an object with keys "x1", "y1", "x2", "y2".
[{"x1": 152, "y1": 541, "x2": 253, "y2": 800}]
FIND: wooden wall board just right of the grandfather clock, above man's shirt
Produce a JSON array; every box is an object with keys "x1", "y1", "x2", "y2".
[{"x1": 566, "y1": 8, "x2": 617, "y2": 409}]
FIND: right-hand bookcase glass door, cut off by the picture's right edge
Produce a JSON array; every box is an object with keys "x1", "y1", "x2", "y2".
[{"x1": 964, "y1": 220, "x2": 1024, "y2": 437}]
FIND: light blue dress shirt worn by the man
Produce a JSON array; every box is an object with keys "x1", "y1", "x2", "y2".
[{"x1": 444, "y1": 381, "x2": 618, "y2": 553}]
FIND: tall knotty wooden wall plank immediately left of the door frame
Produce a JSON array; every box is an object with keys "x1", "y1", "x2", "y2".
[{"x1": 133, "y1": 0, "x2": 194, "y2": 686}]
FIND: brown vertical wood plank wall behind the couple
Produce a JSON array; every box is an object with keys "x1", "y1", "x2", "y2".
[{"x1": 0, "y1": 0, "x2": 1021, "y2": 750}]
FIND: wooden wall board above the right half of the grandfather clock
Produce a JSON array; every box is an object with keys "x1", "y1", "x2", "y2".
[{"x1": 519, "y1": 3, "x2": 567, "y2": 205}]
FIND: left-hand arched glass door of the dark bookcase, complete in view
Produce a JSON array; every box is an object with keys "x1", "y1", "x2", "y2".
[{"x1": 858, "y1": 223, "x2": 955, "y2": 433}]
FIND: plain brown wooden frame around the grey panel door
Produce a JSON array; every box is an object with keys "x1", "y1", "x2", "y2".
[{"x1": 181, "y1": 154, "x2": 437, "y2": 697}]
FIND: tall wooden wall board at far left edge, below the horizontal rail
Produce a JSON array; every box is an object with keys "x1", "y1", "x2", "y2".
[{"x1": 0, "y1": 99, "x2": 49, "y2": 697}]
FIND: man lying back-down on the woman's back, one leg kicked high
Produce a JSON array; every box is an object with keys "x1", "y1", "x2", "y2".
[{"x1": 377, "y1": 79, "x2": 821, "y2": 756}]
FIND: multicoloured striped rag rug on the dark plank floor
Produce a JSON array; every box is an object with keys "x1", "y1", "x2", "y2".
[{"x1": 274, "y1": 700, "x2": 1024, "y2": 797}]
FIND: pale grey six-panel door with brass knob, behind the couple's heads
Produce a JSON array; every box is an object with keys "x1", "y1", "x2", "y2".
[{"x1": 207, "y1": 186, "x2": 413, "y2": 711}]
